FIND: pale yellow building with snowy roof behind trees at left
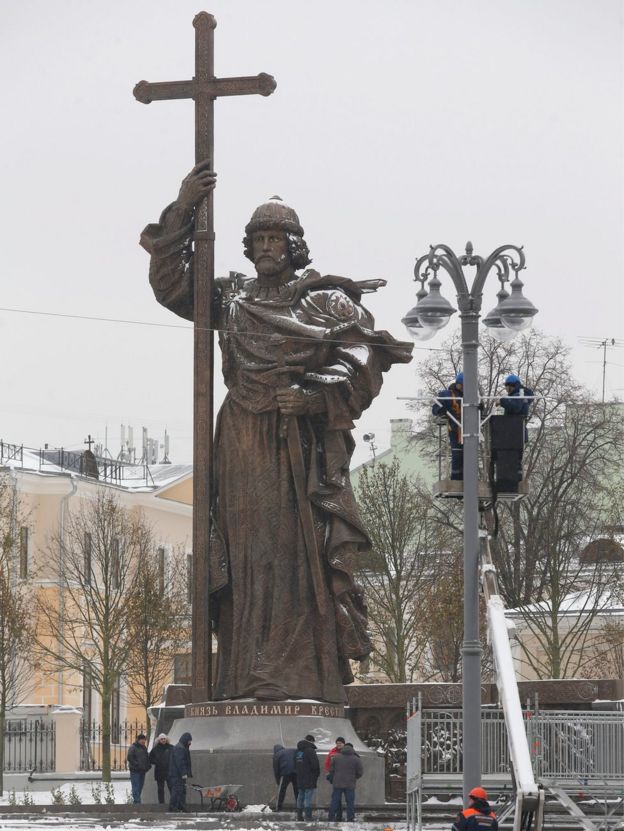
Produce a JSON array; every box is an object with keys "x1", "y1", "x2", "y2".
[{"x1": 0, "y1": 443, "x2": 192, "y2": 724}]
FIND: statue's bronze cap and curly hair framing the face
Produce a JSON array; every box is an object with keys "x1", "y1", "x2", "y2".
[{"x1": 243, "y1": 196, "x2": 312, "y2": 271}]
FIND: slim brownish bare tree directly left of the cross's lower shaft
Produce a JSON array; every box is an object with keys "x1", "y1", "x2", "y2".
[{"x1": 127, "y1": 544, "x2": 190, "y2": 738}]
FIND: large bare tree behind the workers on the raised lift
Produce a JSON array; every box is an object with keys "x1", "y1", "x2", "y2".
[{"x1": 414, "y1": 332, "x2": 624, "y2": 678}]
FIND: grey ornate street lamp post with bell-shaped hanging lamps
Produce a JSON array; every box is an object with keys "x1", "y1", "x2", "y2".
[{"x1": 403, "y1": 242, "x2": 537, "y2": 801}]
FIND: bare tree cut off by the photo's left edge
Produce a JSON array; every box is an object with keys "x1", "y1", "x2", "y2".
[{"x1": 0, "y1": 474, "x2": 32, "y2": 796}]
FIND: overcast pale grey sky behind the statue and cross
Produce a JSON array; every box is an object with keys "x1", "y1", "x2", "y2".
[{"x1": 0, "y1": 0, "x2": 624, "y2": 462}]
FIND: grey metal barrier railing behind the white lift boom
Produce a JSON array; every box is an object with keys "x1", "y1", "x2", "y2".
[{"x1": 422, "y1": 709, "x2": 624, "y2": 784}]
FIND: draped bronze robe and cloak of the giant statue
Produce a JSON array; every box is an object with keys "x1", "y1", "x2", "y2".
[{"x1": 142, "y1": 203, "x2": 411, "y2": 702}]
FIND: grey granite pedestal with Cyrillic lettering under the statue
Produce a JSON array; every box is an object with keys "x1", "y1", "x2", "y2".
[{"x1": 142, "y1": 699, "x2": 385, "y2": 808}]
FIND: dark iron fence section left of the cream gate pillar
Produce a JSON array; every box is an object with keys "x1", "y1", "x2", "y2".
[{"x1": 3, "y1": 718, "x2": 56, "y2": 773}]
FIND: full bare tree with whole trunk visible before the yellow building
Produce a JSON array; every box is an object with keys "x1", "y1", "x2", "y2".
[{"x1": 37, "y1": 490, "x2": 148, "y2": 781}]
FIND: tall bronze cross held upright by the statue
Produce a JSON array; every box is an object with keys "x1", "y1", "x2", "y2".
[{"x1": 134, "y1": 12, "x2": 276, "y2": 702}]
